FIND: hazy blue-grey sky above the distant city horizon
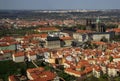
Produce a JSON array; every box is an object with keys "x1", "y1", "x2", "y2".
[{"x1": 0, "y1": 0, "x2": 120, "y2": 10}]
